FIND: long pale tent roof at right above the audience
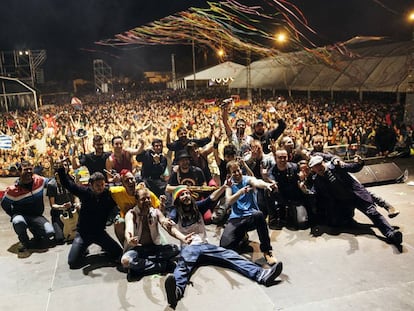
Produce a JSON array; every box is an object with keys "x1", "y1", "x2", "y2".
[{"x1": 230, "y1": 41, "x2": 414, "y2": 92}]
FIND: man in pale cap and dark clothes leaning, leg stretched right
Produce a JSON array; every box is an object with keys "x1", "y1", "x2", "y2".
[{"x1": 308, "y1": 155, "x2": 403, "y2": 246}]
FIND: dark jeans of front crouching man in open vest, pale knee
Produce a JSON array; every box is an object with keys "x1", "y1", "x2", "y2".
[{"x1": 121, "y1": 244, "x2": 180, "y2": 275}]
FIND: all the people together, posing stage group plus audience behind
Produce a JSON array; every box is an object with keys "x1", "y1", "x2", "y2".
[{"x1": 1, "y1": 92, "x2": 412, "y2": 308}]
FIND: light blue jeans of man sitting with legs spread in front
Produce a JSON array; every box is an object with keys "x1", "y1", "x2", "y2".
[{"x1": 174, "y1": 243, "x2": 263, "y2": 295}]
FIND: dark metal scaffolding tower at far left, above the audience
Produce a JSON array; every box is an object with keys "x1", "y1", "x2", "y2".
[{"x1": 0, "y1": 50, "x2": 46, "y2": 87}]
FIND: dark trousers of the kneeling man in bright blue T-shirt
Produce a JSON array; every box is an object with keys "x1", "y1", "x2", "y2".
[{"x1": 220, "y1": 211, "x2": 272, "y2": 252}]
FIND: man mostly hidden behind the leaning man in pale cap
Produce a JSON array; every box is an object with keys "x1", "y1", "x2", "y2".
[{"x1": 310, "y1": 134, "x2": 400, "y2": 218}]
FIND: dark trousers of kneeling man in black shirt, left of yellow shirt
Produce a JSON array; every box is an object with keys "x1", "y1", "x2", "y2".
[{"x1": 68, "y1": 231, "x2": 122, "y2": 269}]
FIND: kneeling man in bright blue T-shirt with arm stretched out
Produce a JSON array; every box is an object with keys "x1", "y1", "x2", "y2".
[{"x1": 220, "y1": 161, "x2": 277, "y2": 265}]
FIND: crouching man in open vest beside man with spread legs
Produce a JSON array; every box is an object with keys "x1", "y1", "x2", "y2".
[{"x1": 121, "y1": 187, "x2": 180, "y2": 281}]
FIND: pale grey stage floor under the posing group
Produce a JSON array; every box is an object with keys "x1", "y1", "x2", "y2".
[{"x1": 0, "y1": 158, "x2": 414, "y2": 311}]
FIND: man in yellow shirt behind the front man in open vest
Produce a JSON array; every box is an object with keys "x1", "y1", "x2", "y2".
[{"x1": 109, "y1": 169, "x2": 162, "y2": 245}]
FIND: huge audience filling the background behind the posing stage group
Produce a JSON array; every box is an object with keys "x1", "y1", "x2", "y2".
[{"x1": 0, "y1": 92, "x2": 412, "y2": 176}]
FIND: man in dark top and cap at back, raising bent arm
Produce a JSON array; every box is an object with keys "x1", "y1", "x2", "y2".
[{"x1": 246, "y1": 113, "x2": 286, "y2": 153}]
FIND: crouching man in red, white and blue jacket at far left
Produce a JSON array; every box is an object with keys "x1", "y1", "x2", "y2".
[{"x1": 1, "y1": 160, "x2": 55, "y2": 253}]
